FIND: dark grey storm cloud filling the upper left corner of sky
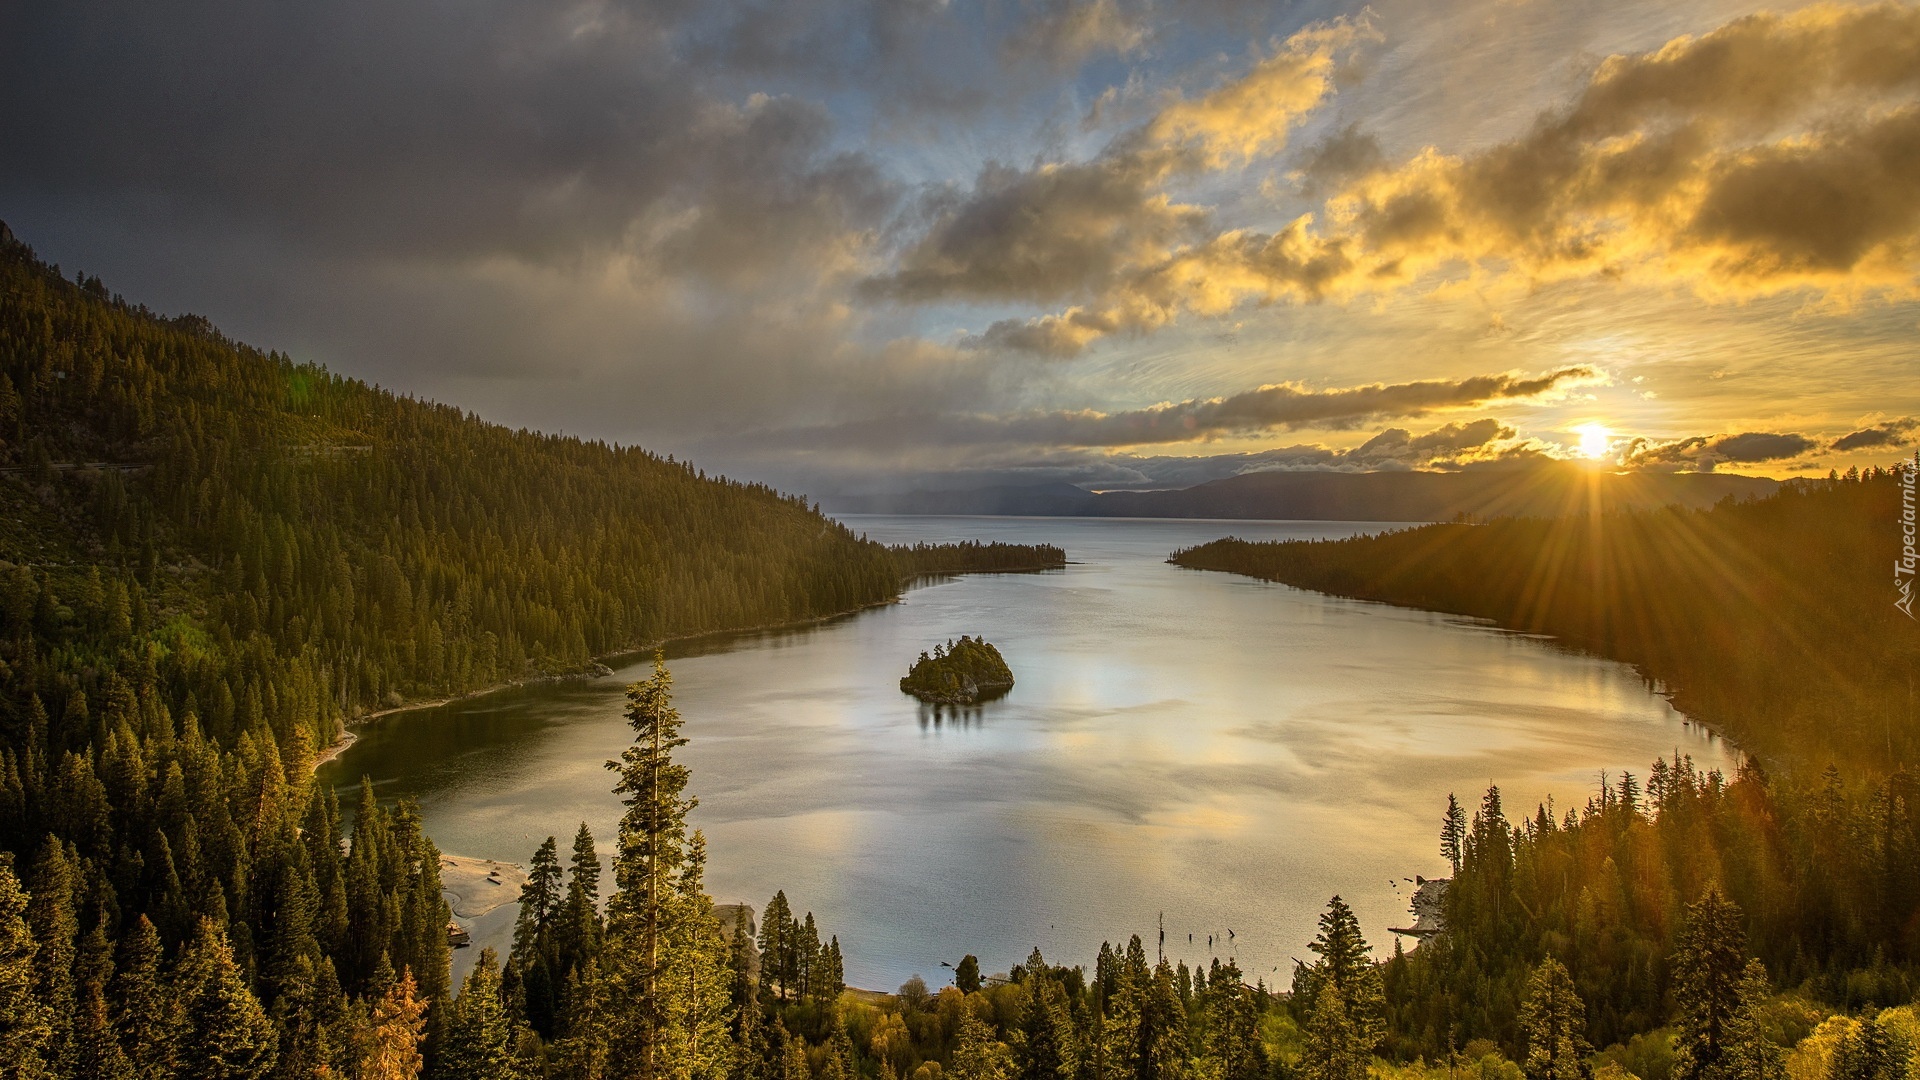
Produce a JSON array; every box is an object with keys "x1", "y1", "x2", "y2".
[{"x1": 0, "y1": 0, "x2": 890, "y2": 269}]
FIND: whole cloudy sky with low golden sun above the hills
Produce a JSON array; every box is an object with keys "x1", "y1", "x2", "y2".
[{"x1": 0, "y1": 0, "x2": 1920, "y2": 496}]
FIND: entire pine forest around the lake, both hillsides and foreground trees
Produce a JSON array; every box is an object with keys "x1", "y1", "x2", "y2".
[{"x1": 0, "y1": 216, "x2": 1920, "y2": 1080}]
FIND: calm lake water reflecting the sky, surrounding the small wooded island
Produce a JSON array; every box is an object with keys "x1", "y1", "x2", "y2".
[{"x1": 328, "y1": 517, "x2": 1732, "y2": 990}]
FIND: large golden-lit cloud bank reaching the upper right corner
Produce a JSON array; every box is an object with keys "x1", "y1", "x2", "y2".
[{"x1": 1331, "y1": 4, "x2": 1920, "y2": 296}]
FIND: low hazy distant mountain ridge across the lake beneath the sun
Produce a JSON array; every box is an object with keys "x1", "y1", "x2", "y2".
[{"x1": 831, "y1": 463, "x2": 1780, "y2": 521}]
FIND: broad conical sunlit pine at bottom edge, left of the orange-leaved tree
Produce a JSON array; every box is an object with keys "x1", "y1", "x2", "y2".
[{"x1": 173, "y1": 919, "x2": 276, "y2": 1080}]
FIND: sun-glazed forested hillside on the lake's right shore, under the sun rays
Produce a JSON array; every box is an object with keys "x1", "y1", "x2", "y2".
[{"x1": 1173, "y1": 469, "x2": 1920, "y2": 780}]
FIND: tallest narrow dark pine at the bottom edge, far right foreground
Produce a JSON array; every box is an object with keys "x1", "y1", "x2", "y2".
[{"x1": 1672, "y1": 886, "x2": 1747, "y2": 1080}]
